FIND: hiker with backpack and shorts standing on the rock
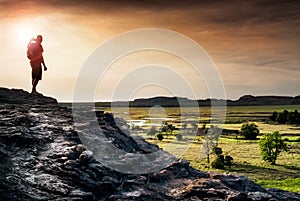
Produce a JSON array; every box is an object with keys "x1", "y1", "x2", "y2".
[{"x1": 27, "y1": 35, "x2": 47, "y2": 94}]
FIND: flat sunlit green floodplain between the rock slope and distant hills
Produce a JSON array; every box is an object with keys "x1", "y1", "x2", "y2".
[{"x1": 62, "y1": 105, "x2": 300, "y2": 193}]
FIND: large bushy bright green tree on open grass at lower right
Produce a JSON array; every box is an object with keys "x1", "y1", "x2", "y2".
[{"x1": 259, "y1": 131, "x2": 287, "y2": 165}]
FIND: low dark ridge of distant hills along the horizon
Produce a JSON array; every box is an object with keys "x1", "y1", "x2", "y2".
[{"x1": 96, "y1": 95, "x2": 300, "y2": 107}]
